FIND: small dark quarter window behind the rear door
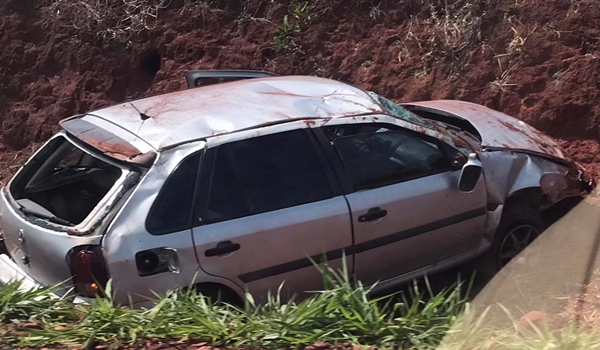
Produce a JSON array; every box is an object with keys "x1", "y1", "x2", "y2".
[{"x1": 146, "y1": 153, "x2": 200, "y2": 235}]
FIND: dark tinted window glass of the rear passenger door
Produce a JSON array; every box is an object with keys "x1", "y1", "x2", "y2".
[{"x1": 198, "y1": 130, "x2": 332, "y2": 224}]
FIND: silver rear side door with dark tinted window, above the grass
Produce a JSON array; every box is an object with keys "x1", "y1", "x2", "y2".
[{"x1": 193, "y1": 129, "x2": 352, "y2": 299}]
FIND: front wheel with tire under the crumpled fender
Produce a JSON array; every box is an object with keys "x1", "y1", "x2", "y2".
[{"x1": 478, "y1": 204, "x2": 546, "y2": 279}]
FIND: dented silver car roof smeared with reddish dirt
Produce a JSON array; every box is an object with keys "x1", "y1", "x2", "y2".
[{"x1": 75, "y1": 76, "x2": 384, "y2": 150}]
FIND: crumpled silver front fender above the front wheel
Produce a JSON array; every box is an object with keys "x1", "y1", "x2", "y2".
[{"x1": 478, "y1": 151, "x2": 579, "y2": 204}]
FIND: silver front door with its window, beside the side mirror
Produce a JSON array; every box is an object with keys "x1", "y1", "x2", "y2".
[{"x1": 317, "y1": 123, "x2": 486, "y2": 284}]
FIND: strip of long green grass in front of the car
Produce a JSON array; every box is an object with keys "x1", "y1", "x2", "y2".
[{"x1": 0, "y1": 266, "x2": 600, "y2": 350}]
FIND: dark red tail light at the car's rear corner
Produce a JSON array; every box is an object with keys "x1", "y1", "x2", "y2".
[{"x1": 67, "y1": 246, "x2": 108, "y2": 297}]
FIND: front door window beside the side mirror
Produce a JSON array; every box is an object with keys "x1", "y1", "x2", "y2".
[{"x1": 325, "y1": 125, "x2": 450, "y2": 190}]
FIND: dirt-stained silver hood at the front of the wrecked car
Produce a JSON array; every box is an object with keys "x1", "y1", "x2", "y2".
[{"x1": 403, "y1": 100, "x2": 572, "y2": 162}]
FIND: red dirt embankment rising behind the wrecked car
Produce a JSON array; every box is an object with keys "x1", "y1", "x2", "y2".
[{"x1": 0, "y1": 0, "x2": 600, "y2": 180}]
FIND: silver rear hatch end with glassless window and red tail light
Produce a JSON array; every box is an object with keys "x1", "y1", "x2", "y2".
[{"x1": 0, "y1": 131, "x2": 143, "y2": 297}]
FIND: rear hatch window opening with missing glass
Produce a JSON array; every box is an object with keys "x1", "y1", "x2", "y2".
[{"x1": 10, "y1": 136, "x2": 122, "y2": 226}]
